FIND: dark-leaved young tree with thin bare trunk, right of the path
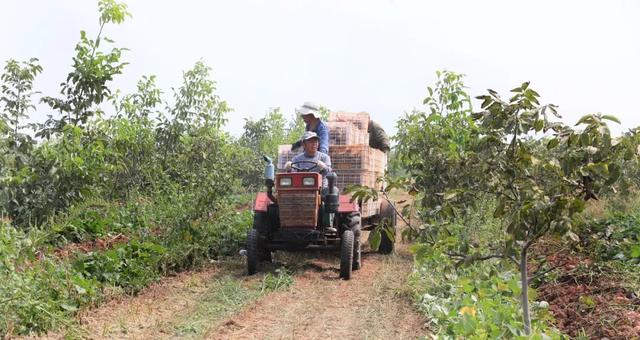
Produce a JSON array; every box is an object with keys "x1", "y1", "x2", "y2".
[{"x1": 470, "y1": 83, "x2": 627, "y2": 334}]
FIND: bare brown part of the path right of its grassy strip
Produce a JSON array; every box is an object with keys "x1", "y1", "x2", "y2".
[{"x1": 206, "y1": 244, "x2": 428, "y2": 339}]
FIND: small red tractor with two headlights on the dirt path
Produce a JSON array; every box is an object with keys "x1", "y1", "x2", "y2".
[{"x1": 246, "y1": 157, "x2": 395, "y2": 280}]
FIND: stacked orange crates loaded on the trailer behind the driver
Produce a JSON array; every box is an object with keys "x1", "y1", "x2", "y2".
[{"x1": 278, "y1": 112, "x2": 387, "y2": 217}]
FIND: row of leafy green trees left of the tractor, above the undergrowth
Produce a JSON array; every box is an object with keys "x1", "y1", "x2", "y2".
[{"x1": 0, "y1": 0, "x2": 303, "y2": 227}]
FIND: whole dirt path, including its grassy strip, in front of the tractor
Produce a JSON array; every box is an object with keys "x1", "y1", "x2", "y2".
[{"x1": 48, "y1": 240, "x2": 428, "y2": 339}]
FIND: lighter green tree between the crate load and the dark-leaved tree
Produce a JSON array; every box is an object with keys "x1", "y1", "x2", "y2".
[{"x1": 395, "y1": 71, "x2": 482, "y2": 231}]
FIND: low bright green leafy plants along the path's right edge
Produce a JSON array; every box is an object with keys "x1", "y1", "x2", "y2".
[{"x1": 412, "y1": 240, "x2": 561, "y2": 339}]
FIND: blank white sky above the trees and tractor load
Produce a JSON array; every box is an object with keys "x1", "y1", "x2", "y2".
[{"x1": 0, "y1": 0, "x2": 640, "y2": 135}]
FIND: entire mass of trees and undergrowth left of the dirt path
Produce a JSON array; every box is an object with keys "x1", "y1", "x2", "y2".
[{"x1": 0, "y1": 0, "x2": 260, "y2": 337}]
